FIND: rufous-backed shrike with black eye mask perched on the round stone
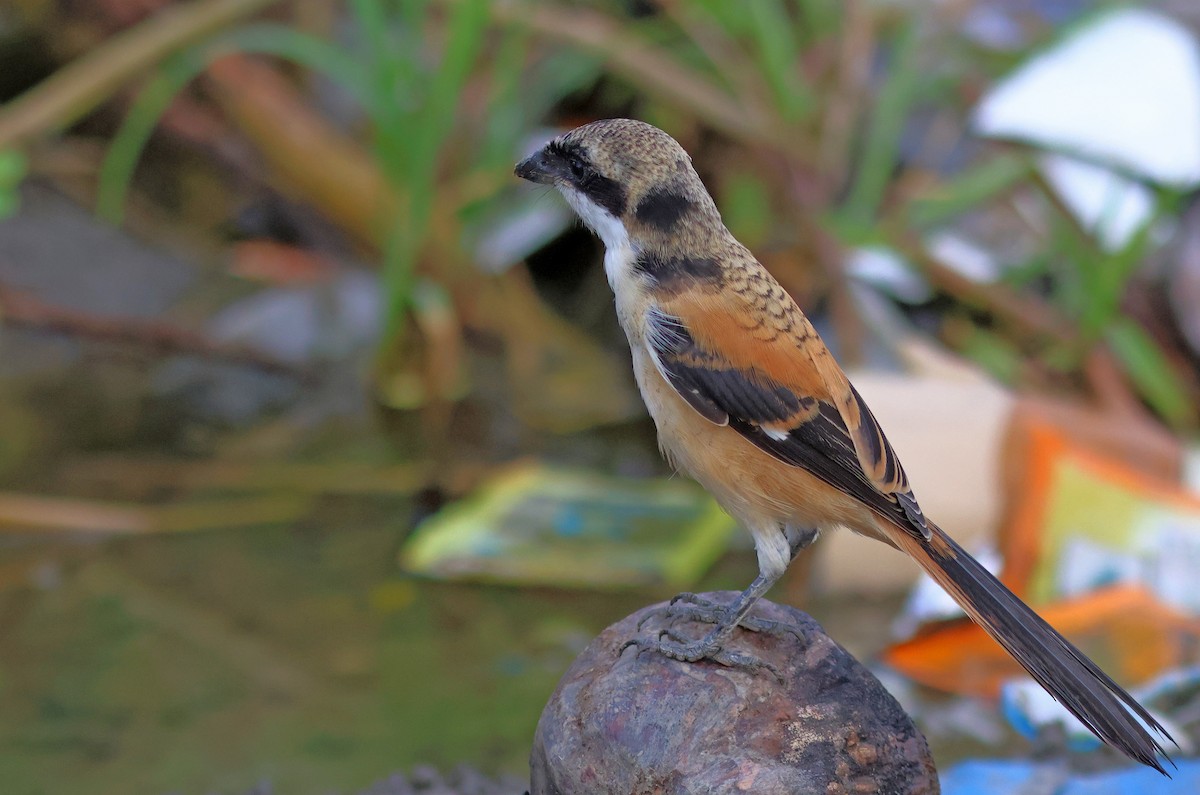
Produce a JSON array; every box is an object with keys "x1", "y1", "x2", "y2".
[{"x1": 515, "y1": 119, "x2": 1174, "y2": 775}]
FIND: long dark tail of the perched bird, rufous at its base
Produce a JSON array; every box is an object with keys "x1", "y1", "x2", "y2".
[{"x1": 889, "y1": 524, "x2": 1175, "y2": 776}]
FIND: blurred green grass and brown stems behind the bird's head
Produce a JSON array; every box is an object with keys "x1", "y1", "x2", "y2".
[{"x1": 0, "y1": 0, "x2": 1196, "y2": 430}]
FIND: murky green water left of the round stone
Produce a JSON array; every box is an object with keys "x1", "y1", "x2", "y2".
[{"x1": 0, "y1": 504, "x2": 650, "y2": 795}]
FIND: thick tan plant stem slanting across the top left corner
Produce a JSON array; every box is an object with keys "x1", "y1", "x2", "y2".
[{"x1": 0, "y1": 0, "x2": 277, "y2": 150}]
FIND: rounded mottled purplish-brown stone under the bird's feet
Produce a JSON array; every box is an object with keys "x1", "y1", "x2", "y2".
[{"x1": 530, "y1": 592, "x2": 938, "y2": 795}]
